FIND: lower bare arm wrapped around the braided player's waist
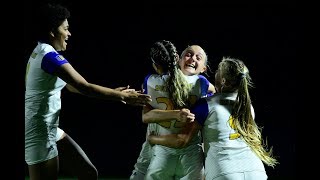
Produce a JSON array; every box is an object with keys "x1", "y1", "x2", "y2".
[{"x1": 147, "y1": 121, "x2": 201, "y2": 148}]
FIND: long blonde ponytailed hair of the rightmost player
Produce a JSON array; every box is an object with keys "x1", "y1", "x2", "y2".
[{"x1": 218, "y1": 57, "x2": 278, "y2": 167}]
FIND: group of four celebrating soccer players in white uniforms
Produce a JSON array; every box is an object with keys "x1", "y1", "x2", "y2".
[{"x1": 25, "y1": 4, "x2": 278, "y2": 180}]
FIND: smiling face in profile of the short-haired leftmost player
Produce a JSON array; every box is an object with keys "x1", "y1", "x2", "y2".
[{"x1": 50, "y1": 19, "x2": 71, "y2": 51}]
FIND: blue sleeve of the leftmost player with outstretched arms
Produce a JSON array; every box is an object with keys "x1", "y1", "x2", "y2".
[{"x1": 41, "y1": 52, "x2": 68, "y2": 74}]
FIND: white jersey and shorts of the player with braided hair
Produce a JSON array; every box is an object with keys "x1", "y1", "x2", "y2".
[{"x1": 144, "y1": 75, "x2": 209, "y2": 180}]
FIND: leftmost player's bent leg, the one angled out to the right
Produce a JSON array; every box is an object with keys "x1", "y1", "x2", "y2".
[{"x1": 57, "y1": 134, "x2": 98, "y2": 180}]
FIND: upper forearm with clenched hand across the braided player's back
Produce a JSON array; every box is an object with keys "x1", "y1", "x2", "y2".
[{"x1": 142, "y1": 105, "x2": 195, "y2": 123}]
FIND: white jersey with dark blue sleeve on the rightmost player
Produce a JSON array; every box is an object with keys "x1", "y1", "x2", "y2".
[{"x1": 192, "y1": 93, "x2": 265, "y2": 179}]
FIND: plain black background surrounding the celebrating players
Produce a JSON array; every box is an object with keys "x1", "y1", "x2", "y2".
[{"x1": 22, "y1": 0, "x2": 301, "y2": 180}]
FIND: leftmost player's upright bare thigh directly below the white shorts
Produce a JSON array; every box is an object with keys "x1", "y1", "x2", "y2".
[{"x1": 28, "y1": 157, "x2": 59, "y2": 180}]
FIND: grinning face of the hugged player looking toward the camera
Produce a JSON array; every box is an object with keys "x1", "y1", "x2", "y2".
[{"x1": 179, "y1": 45, "x2": 207, "y2": 76}]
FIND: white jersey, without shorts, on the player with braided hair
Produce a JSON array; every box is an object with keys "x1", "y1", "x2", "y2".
[{"x1": 144, "y1": 74, "x2": 209, "y2": 155}]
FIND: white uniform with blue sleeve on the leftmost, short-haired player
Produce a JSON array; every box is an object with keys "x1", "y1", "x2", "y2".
[{"x1": 25, "y1": 42, "x2": 68, "y2": 165}]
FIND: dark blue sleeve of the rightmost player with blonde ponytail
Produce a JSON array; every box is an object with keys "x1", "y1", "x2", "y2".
[{"x1": 191, "y1": 98, "x2": 209, "y2": 126}]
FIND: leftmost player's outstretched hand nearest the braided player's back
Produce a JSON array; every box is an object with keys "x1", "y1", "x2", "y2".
[{"x1": 122, "y1": 90, "x2": 152, "y2": 106}]
